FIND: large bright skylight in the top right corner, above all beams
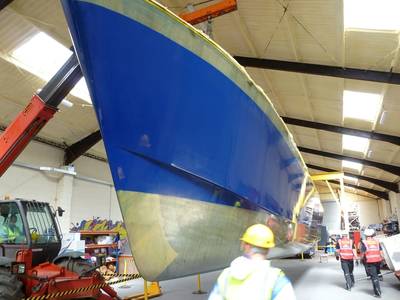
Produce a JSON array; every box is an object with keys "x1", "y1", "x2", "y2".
[{"x1": 344, "y1": 0, "x2": 400, "y2": 30}]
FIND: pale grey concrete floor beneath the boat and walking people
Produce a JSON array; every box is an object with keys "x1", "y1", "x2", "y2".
[{"x1": 145, "y1": 257, "x2": 400, "y2": 300}]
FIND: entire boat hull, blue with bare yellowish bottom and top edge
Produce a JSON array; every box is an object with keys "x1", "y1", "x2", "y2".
[{"x1": 62, "y1": 0, "x2": 324, "y2": 280}]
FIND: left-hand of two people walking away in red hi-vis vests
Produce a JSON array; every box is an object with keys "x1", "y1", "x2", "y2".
[{"x1": 336, "y1": 233, "x2": 357, "y2": 291}]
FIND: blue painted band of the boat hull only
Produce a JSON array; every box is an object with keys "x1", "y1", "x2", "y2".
[{"x1": 64, "y1": 1, "x2": 303, "y2": 219}]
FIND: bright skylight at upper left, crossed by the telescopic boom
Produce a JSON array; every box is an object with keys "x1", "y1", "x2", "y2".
[{"x1": 11, "y1": 32, "x2": 92, "y2": 103}]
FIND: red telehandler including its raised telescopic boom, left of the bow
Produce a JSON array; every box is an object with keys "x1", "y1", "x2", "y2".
[{"x1": 0, "y1": 54, "x2": 118, "y2": 300}]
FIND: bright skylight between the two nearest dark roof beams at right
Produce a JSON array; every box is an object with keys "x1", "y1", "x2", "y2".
[{"x1": 343, "y1": 90, "x2": 382, "y2": 123}]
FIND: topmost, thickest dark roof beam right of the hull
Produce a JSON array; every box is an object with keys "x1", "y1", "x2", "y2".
[{"x1": 234, "y1": 56, "x2": 400, "y2": 84}]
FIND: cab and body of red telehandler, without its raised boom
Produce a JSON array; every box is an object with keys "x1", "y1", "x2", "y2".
[{"x1": 0, "y1": 199, "x2": 118, "y2": 300}]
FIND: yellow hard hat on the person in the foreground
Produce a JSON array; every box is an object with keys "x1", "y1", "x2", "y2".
[{"x1": 240, "y1": 224, "x2": 275, "y2": 248}]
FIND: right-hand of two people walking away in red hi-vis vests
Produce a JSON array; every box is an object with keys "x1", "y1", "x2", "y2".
[{"x1": 361, "y1": 228, "x2": 383, "y2": 298}]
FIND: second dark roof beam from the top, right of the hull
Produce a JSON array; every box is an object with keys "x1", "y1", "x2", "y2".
[{"x1": 282, "y1": 117, "x2": 400, "y2": 146}]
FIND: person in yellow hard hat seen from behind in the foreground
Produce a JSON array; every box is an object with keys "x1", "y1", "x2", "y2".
[{"x1": 208, "y1": 224, "x2": 296, "y2": 300}]
